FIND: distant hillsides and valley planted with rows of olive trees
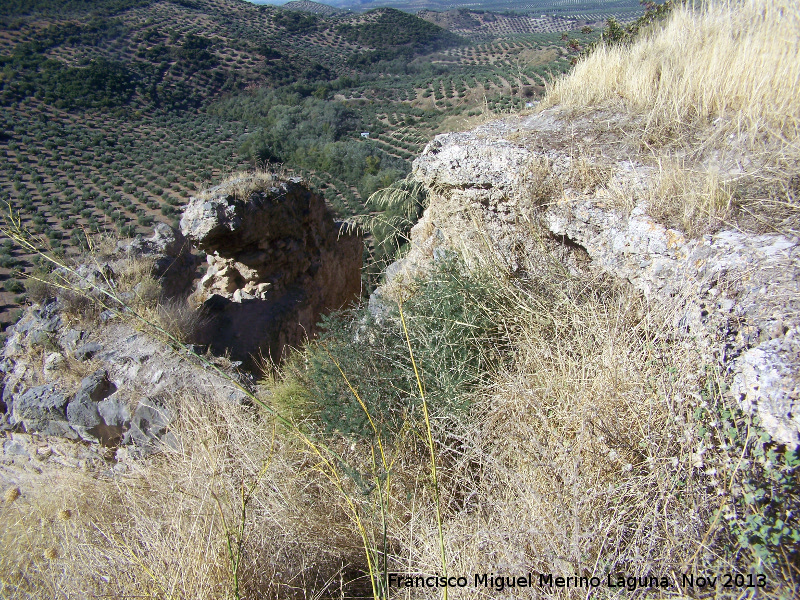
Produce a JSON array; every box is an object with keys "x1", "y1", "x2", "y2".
[{"x1": 0, "y1": 0, "x2": 597, "y2": 327}]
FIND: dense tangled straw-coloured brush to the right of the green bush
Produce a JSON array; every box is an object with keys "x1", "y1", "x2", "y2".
[{"x1": 390, "y1": 274, "x2": 719, "y2": 598}]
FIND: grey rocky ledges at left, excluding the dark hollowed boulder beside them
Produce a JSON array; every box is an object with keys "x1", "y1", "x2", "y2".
[{"x1": 0, "y1": 224, "x2": 249, "y2": 456}]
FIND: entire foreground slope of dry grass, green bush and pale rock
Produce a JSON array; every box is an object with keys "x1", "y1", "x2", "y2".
[{"x1": 0, "y1": 0, "x2": 800, "y2": 600}]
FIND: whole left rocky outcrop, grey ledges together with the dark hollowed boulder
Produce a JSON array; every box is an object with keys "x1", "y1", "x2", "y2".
[{"x1": 0, "y1": 178, "x2": 362, "y2": 452}]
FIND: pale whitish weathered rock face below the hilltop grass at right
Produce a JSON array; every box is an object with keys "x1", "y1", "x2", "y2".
[{"x1": 382, "y1": 112, "x2": 800, "y2": 445}]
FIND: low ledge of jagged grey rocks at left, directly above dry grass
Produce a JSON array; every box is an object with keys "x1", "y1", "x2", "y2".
[{"x1": 0, "y1": 299, "x2": 251, "y2": 454}]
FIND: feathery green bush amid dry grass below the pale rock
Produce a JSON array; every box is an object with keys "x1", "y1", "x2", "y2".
[{"x1": 299, "y1": 257, "x2": 509, "y2": 437}]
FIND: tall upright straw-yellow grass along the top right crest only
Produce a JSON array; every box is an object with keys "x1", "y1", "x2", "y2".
[{"x1": 545, "y1": 0, "x2": 800, "y2": 145}]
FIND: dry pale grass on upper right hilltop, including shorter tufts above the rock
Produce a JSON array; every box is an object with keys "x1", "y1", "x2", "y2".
[{"x1": 543, "y1": 0, "x2": 800, "y2": 234}]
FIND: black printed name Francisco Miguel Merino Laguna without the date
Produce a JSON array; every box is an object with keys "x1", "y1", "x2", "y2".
[{"x1": 389, "y1": 573, "x2": 670, "y2": 592}]
